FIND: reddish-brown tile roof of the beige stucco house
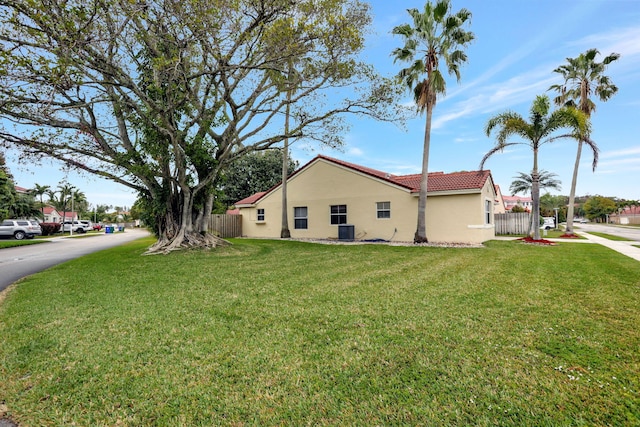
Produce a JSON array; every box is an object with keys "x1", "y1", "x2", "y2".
[{"x1": 236, "y1": 155, "x2": 491, "y2": 206}]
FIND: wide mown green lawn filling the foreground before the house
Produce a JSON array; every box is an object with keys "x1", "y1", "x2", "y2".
[{"x1": 0, "y1": 239, "x2": 640, "y2": 426}]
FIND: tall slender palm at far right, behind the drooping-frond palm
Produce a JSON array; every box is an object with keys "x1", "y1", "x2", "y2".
[{"x1": 549, "y1": 49, "x2": 620, "y2": 234}]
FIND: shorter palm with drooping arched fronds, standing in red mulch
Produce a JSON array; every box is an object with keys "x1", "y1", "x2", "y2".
[{"x1": 480, "y1": 95, "x2": 593, "y2": 240}]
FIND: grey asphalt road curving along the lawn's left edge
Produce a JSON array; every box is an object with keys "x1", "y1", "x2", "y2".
[{"x1": 0, "y1": 228, "x2": 149, "y2": 292}]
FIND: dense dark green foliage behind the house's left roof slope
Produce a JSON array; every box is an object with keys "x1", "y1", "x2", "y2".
[{"x1": 221, "y1": 149, "x2": 298, "y2": 206}]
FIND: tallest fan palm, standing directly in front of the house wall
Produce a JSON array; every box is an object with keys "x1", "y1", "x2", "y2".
[{"x1": 392, "y1": 0, "x2": 475, "y2": 243}]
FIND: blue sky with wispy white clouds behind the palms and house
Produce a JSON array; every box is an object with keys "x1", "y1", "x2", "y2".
[{"x1": 7, "y1": 0, "x2": 640, "y2": 206}]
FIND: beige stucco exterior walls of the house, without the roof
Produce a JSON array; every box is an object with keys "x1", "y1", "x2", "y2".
[{"x1": 240, "y1": 161, "x2": 494, "y2": 243}]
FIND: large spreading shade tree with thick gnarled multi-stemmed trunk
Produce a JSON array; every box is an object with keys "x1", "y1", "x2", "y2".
[{"x1": 0, "y1": 0, "x2": 397, "y2": 252}]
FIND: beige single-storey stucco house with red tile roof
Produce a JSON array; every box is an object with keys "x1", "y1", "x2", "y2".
[{"x1": 236, "y1": 156, "x2": 496, "y2": 243}]
